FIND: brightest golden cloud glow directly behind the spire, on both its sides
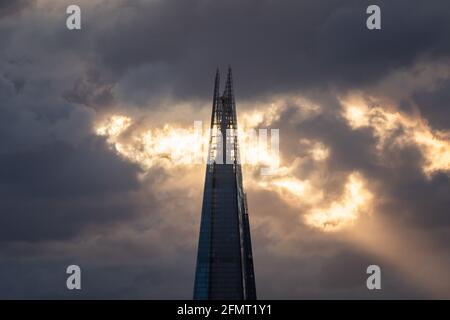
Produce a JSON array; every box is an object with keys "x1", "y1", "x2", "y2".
[{"x1": 95, "y1": 115, "x2": 280, "y2": 170}]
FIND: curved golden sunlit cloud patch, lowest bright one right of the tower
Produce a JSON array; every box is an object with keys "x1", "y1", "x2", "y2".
[{"x1": 305, "y1": 172, "x2": 373, "y2": 231}]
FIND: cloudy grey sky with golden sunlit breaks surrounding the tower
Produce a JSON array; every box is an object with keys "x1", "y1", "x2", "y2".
[{"x1": 0, "y1": 0, "x2": 450, "y2": 299}]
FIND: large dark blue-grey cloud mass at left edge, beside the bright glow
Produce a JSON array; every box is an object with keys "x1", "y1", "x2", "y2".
[{"x1": 0, "y1": 64, "x2": 142, "y2": 242}]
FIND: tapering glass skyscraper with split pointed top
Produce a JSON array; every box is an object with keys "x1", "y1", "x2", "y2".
[{"x1": 194, "y1": 68, "x2": 256, "y2": 300}]
